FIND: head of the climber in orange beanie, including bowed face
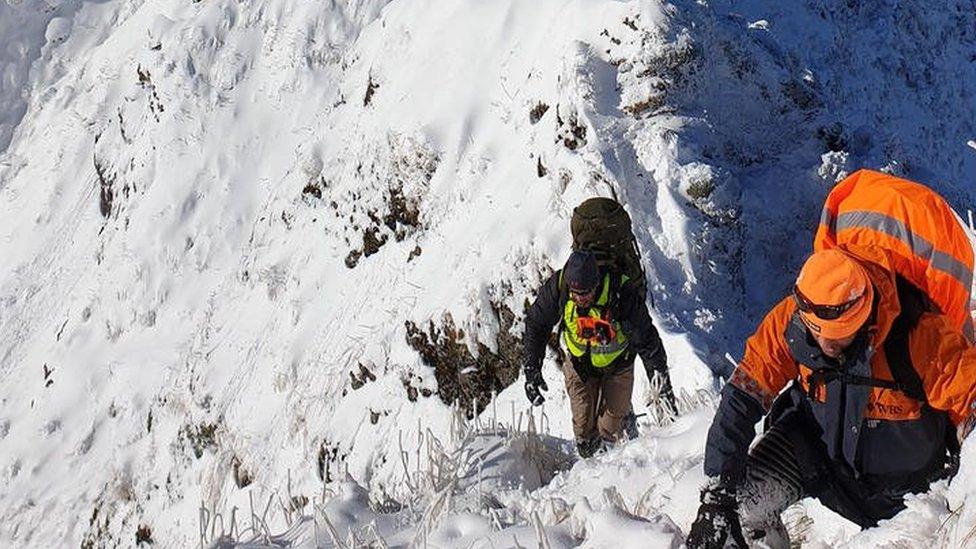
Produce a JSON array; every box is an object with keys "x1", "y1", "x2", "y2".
[{"x1": 793, "y1": 250, "x2": 874, "y2": 358}]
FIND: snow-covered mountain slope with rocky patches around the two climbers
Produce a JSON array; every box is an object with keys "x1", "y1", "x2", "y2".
[{"x1": 0, "y1": 0, "x2": 976, "y2": 547}]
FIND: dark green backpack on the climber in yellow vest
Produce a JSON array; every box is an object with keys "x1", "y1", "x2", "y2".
[{"x1": 569, "y1": 197, "x2": 647, "y2": 297}]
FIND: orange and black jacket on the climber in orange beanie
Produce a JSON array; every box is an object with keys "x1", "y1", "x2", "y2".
[{"x1": 704, "y1": 247, "x2": 976, "y2": 484}]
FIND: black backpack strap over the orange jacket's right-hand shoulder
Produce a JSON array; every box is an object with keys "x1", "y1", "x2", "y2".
[{"x1": 884, "y1": 275, "x2": 928, "y2": 404}]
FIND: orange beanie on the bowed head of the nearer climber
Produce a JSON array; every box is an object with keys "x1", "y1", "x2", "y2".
[{"x1": 796, "y1": 249, "x2": 874, "y2": 339}]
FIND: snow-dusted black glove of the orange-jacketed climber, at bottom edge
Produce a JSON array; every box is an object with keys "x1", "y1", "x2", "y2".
[{"x1": 685, "y1": 485, "x2": 748, "y2": 549}]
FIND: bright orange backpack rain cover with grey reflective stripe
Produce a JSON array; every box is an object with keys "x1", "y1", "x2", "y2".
[{"x1": 813, "y1": 170, "x2": 974, "y2": 341}]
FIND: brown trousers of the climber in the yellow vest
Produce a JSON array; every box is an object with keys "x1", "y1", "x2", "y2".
[{"x1": 563, "y1": 360, "x2": 634, "y2": 442}]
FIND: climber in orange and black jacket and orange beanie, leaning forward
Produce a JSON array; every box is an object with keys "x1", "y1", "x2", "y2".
[{"x1": 687, "y1": 246, "x2": 976, "y2": 549}]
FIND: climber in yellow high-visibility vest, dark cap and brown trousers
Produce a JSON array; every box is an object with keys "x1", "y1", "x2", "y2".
[{"x1": 523, "y1": 251, "x2": 675, "y2": 457}]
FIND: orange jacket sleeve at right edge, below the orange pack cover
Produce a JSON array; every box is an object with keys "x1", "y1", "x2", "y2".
[{"x1": 909, "y1": 314, "x2": 976, "y2": 441}]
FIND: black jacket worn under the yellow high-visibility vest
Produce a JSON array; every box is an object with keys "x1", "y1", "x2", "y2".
[{"x1": 522, "y1": 271, "x2": 668, "y2": 379}]
